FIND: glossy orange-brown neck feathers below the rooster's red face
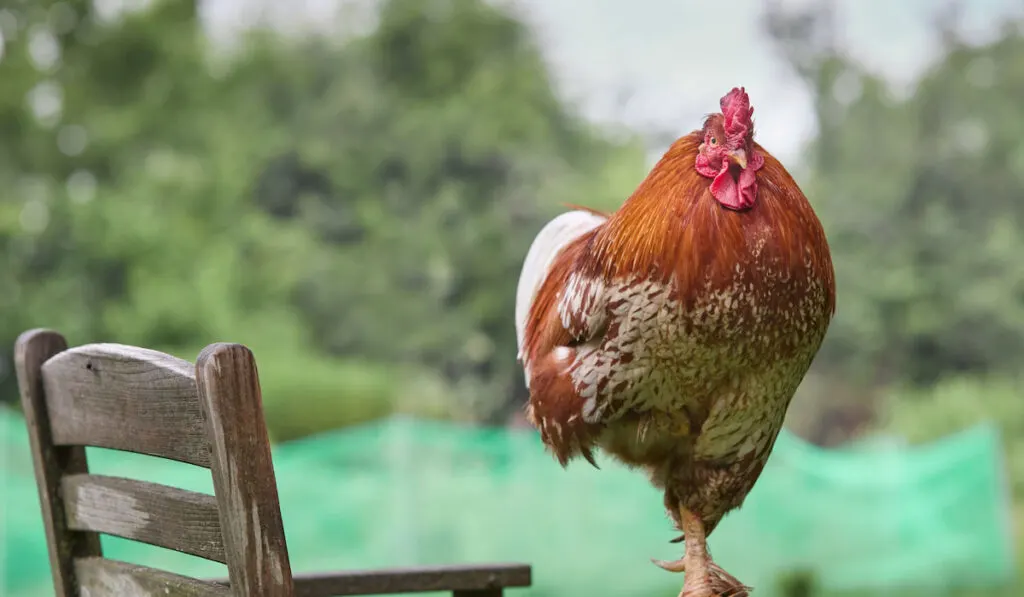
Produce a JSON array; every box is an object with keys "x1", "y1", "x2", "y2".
[{"x1": 579, "y1": 132, "x2": 833, "y2": 315}]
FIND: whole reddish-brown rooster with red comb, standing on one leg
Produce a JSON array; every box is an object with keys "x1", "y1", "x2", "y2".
[{"x1": 515, "y1": 88, "x2": 836, "y2": 597}]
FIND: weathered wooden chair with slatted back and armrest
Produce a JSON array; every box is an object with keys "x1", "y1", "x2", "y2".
[{"x1": 15, "y1": 330, "x2": 530, "y2": 597}]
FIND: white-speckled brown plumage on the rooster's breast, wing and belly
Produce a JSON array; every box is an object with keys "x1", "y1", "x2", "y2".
[{"x1": 529, "y1": 229, "x2": 831, "y2": 527}]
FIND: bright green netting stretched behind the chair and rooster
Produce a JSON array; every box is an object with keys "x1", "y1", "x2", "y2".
[{"x1": 0, "y1": 416, "x2": 1013, "y2": 597}]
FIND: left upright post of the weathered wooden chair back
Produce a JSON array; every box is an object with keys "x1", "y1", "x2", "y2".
[{"x1": 14, "y1": 330, "x2": 101, "y2": 597}]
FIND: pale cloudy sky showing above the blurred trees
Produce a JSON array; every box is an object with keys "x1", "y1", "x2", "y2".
[{"x1": 201, "y1": 0, "x2": 1024, "y2": 162}]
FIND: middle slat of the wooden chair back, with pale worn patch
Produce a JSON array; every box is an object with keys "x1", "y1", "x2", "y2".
[{"x1": 63, "y1": 475, "x2": 226, "y2": 563}]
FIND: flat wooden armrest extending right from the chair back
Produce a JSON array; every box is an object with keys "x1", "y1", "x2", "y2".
[{"x1": 284, "y1": 564, "x2": 531, "y2": 597}]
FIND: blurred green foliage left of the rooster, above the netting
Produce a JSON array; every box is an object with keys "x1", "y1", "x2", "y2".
[{"x1": 0, "y1": 0, "x2": 643, "y2": 439}]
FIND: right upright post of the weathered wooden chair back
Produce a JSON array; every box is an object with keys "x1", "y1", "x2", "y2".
[{"x1": 196, "y1": 343, "x2": 293, "y2": 597}]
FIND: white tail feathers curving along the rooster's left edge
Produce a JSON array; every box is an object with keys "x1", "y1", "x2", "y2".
[{"x1": 515, "y1": 210, "x2": 607, "y2": 383}]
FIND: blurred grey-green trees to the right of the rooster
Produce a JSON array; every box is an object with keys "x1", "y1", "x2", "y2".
[{"x1": 768, "y1": 3, "x2": 1024, "y2": 425}]
